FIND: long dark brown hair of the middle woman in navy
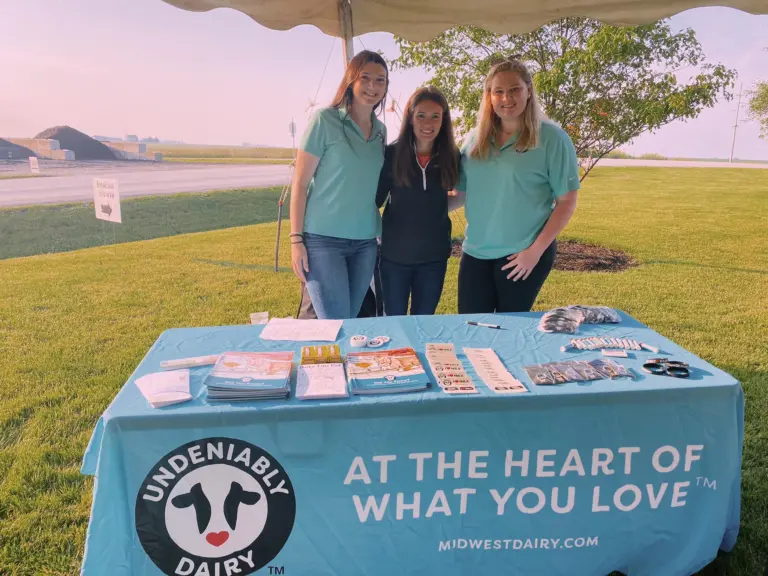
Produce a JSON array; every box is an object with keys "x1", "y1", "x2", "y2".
[{"x1": 392, "y1": 86, "x2": 459, "y2": 190}]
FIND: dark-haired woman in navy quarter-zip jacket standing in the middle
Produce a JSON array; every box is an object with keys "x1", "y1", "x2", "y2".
[{"x1": 376, "y1": 86, "x2": 460, "y2": 316}]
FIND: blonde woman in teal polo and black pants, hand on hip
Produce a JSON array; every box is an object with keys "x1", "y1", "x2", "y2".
[{"x1": 457, "y1": 59, "x2": 580, "y2": 314}]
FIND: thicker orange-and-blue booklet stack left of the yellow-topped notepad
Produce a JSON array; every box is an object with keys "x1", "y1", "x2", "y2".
[{"x1": 205, "y1": 352, "x2": 293, "y2": 402}]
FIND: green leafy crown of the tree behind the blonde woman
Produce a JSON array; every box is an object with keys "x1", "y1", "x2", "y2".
[{"x1": 392, "y1": 18, "x2": 736, "y2": 179}]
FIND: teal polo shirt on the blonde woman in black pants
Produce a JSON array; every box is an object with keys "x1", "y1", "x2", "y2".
[{"x1": 457, "y1": 121, "x2": 580, "y2": 260}]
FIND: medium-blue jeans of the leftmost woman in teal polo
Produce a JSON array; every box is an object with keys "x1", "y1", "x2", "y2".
[{"x1": 304, "y1": 232, "x2": 377, "y2": 320}]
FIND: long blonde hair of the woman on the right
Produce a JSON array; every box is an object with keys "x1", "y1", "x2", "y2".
[{"x1": 469, "y1": 58, "x2": 544, "y2": 160}]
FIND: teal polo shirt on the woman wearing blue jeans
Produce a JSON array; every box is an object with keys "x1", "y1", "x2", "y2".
[{"x1": 300, "y1": 108, "x2": 387, "y2": 240}]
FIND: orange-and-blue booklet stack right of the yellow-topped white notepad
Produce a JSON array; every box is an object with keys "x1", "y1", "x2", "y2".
[{"x1": 347, "y1": 348, "x2": 429, "y2": 394}]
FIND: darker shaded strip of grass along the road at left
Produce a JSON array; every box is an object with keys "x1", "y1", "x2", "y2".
[{"x1": 0, "y1": 188, "x2": 288, "y2": 259}]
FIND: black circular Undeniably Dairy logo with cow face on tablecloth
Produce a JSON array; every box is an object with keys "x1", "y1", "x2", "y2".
[{"x1": 136, "y1": 438, "x2": 296, "y2": 576}]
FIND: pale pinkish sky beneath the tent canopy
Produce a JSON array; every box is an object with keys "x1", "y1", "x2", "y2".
[{"x1": 0, "y1": 0, "x2": 768, "y2": 160}]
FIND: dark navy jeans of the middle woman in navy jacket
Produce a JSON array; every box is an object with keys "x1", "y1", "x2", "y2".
[{"x1": 379, "y1": 258, "x2": 448, "y2": 316}]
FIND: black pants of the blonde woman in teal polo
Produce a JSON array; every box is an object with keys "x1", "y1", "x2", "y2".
[{"x1": 459, "y1": 240, "x2": 557, "y2": 314}]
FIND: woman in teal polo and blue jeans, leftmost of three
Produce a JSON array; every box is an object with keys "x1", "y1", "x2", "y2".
[{"x1": 291, "y1": 50, "x2": 389, "y2": 319}]
